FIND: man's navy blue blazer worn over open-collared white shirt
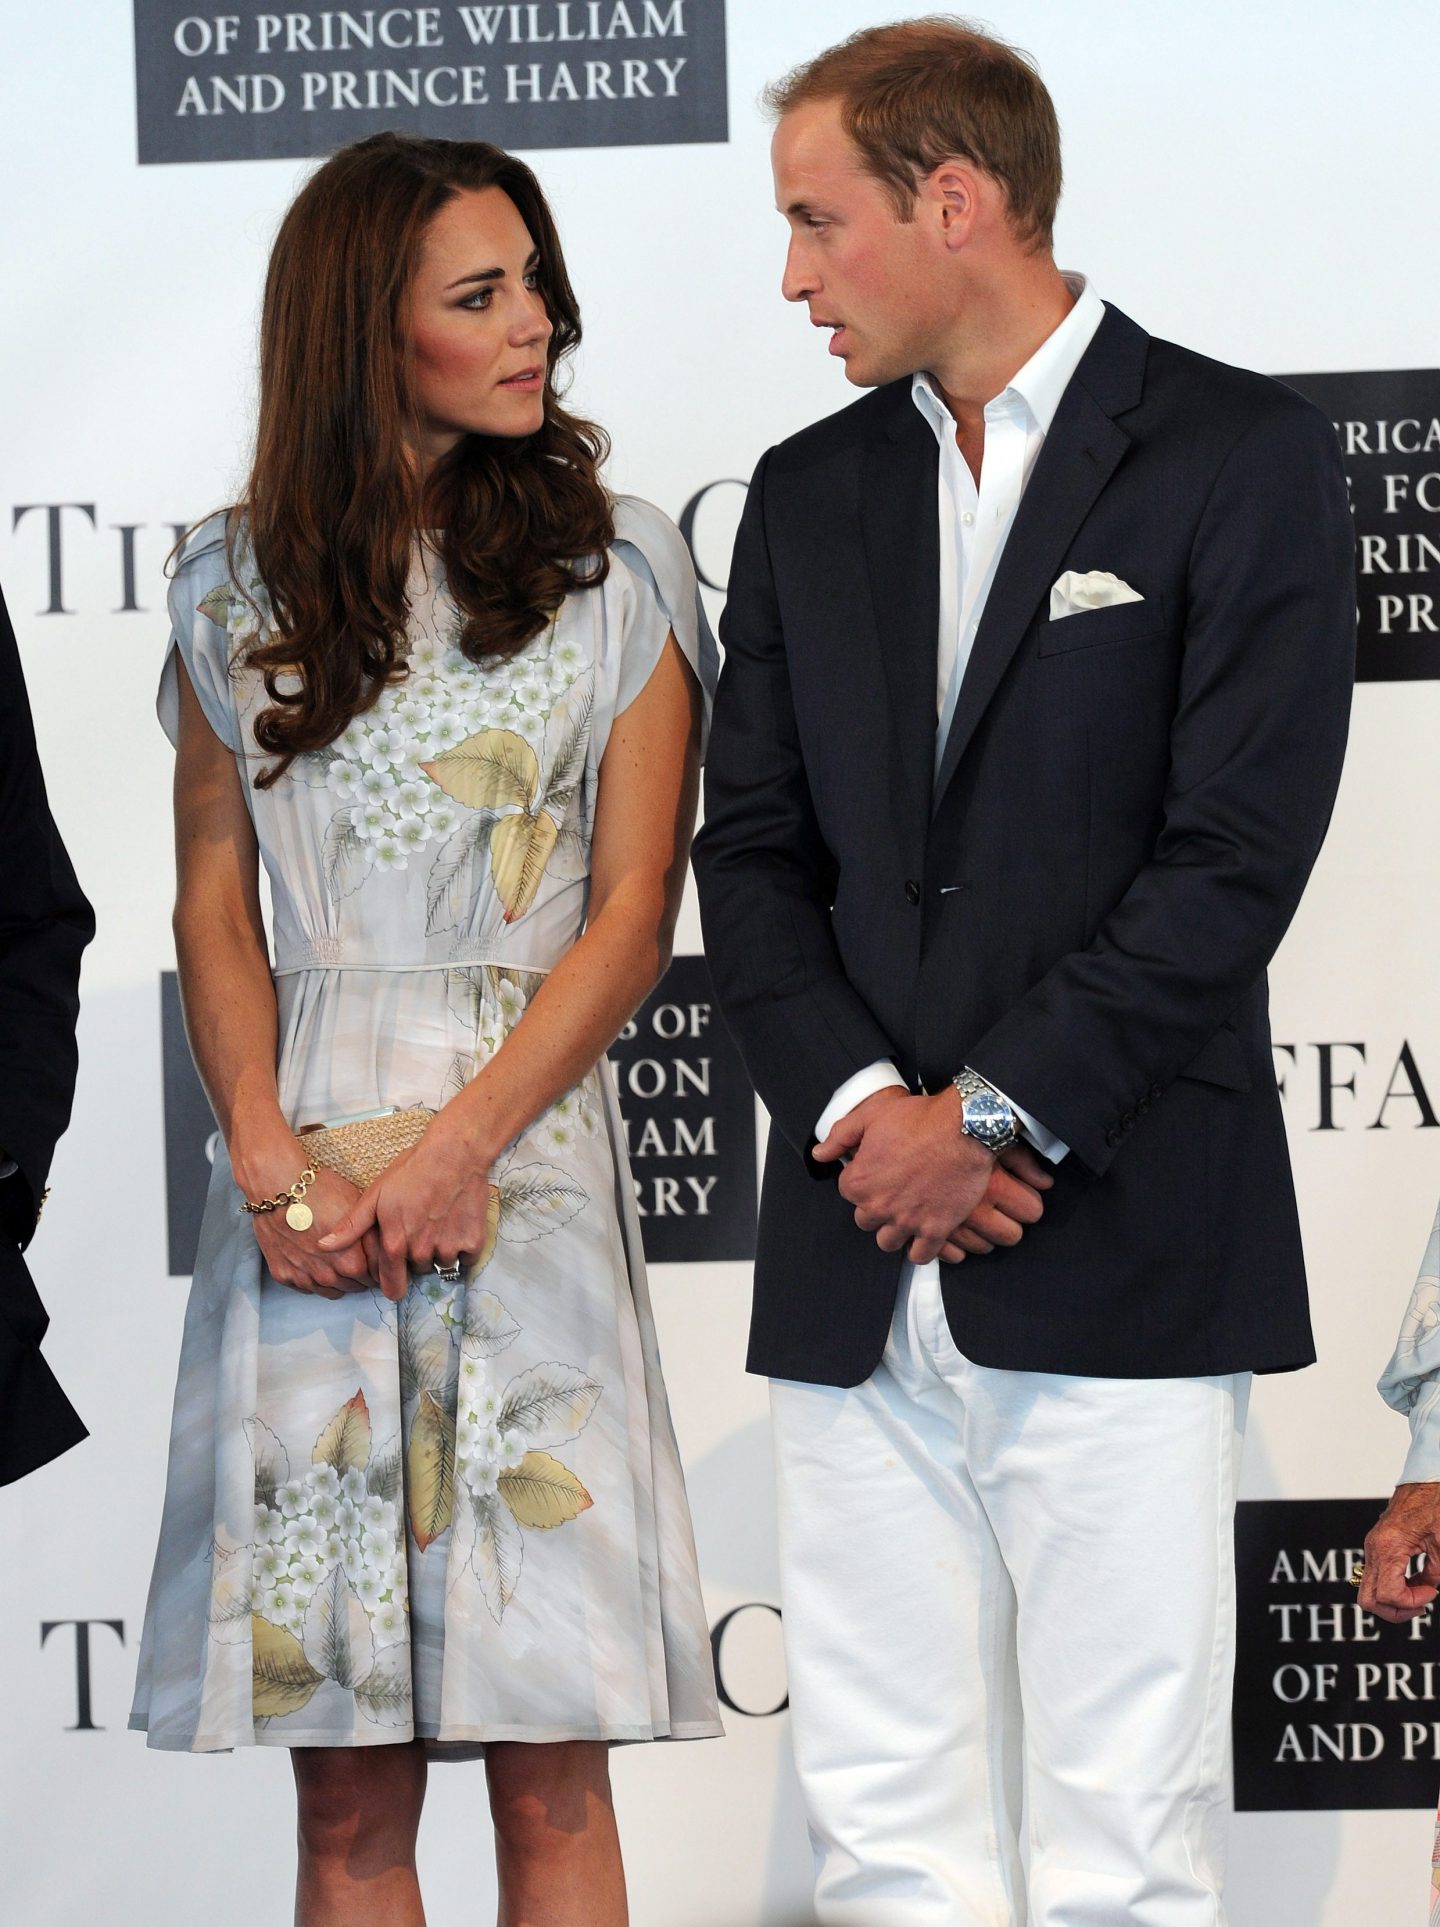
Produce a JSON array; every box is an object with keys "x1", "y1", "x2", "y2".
[{"x1": 694, "y1": 308, "x2": 1355, "y2": 1386}]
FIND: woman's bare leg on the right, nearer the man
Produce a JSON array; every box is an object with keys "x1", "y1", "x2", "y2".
[{"x1": 486, "y1": 1740, "x2": 630, "y2": 1927}]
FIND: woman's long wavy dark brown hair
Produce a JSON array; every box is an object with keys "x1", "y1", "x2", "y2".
[{"x1": 229, "y1": 133, "x2": 615, "y2": 788}]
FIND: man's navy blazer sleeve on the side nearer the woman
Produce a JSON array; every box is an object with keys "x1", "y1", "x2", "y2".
[{"x1": 694, "y1": 455, "x2": 894, "y2": 1175}]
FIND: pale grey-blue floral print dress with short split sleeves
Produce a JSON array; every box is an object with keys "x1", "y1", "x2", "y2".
[{"x1": 131, "y1": 499, "x2": 721, "y2": 1754}]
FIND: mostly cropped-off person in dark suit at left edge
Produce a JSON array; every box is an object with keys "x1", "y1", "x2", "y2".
[{"x1": 0, "y1": 578, "x2": 94, "y2": 1486}]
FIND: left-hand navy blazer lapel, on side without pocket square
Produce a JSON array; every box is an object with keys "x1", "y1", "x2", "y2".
[{"x1": 860, "y1": 395, "x2": 941, "y2": 856}]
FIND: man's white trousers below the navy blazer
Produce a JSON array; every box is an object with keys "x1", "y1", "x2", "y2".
[{"x1": 771, "y1": 1266, "x2": 1249, "y2": 1927}]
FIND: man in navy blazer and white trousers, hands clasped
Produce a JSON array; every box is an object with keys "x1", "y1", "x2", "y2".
[{"x1": 696, "y1": 21, "x2": 1353, "y2": 1927}]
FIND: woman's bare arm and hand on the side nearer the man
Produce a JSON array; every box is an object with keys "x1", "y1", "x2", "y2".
[{"x1": 328, "y1": 636, "x2": 700, "y2": 1295}]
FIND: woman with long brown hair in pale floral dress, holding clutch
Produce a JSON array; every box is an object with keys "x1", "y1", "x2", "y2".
[{"x1": 131, "y1": 135, "x2": 719, "y2": 1927}]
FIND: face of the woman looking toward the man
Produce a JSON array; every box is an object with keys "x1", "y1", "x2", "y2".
[{"x1": 405, "y1": 187, "x2": 551, "y2": 464}]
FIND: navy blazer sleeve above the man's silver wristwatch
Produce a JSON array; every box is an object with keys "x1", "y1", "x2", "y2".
[{"x1": 970, "y1": 405, "x2": 1355, "y2": 1174}]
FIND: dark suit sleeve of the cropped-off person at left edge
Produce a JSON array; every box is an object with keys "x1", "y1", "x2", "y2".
[{"x1": 0, "y1": 599, "x2": 94, "y2": 1245}]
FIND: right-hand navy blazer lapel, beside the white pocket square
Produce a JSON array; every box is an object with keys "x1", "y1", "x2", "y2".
[{"x1": 935, "y1": 308, "x2": 1149, "y2": 809}]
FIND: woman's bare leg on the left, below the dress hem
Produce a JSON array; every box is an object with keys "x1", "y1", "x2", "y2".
[{"x1": 291, "y1": 1740, "x2": 426, "y2": 1927}]
